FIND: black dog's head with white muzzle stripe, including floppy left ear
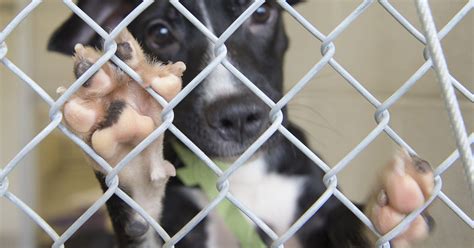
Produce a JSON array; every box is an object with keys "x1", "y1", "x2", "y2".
[{"x1": 49, "y1": 0, "x2": 299, "y2": 157}]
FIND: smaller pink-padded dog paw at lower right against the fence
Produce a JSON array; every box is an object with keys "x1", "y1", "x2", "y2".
[{"x1": 366, "y1": 150, "x2": 434, "y2": 248}]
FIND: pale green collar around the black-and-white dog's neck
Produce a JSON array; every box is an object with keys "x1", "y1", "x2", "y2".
[{"x1": 173, "y1": 142, "x2": 266, "y2": 248}]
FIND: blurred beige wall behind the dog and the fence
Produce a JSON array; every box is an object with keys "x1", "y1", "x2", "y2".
[{"x1": 0, "y1": 0, "x2": 474, "y2": 247}]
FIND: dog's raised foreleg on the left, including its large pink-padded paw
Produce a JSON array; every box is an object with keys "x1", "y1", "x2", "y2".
[{"x1": 59, "y1": 28, "x2": 185, "y2": 247}]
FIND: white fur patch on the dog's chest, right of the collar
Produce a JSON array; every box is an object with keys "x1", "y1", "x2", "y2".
[{"x1": 230, "y1": 158, "x2": 302, "y2": 234}]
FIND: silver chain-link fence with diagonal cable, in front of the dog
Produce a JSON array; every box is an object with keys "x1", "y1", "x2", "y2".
[{"x1": 0, "y1": 0, "x2": 474, "y2": 247}]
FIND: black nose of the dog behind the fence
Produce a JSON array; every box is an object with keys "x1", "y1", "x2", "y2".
[{"x1": 205, "y1": 97, "x2": 269, "y2": 144}]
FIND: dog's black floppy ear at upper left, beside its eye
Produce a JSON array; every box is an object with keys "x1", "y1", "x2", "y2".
[{"x1": 48, "y1": 0, "x2": 138, "y2": 55}]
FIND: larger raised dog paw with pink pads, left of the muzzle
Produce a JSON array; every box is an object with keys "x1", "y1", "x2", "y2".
[{"x1": 58, "y1": 28, "x2": 185, "y2": 176}]
